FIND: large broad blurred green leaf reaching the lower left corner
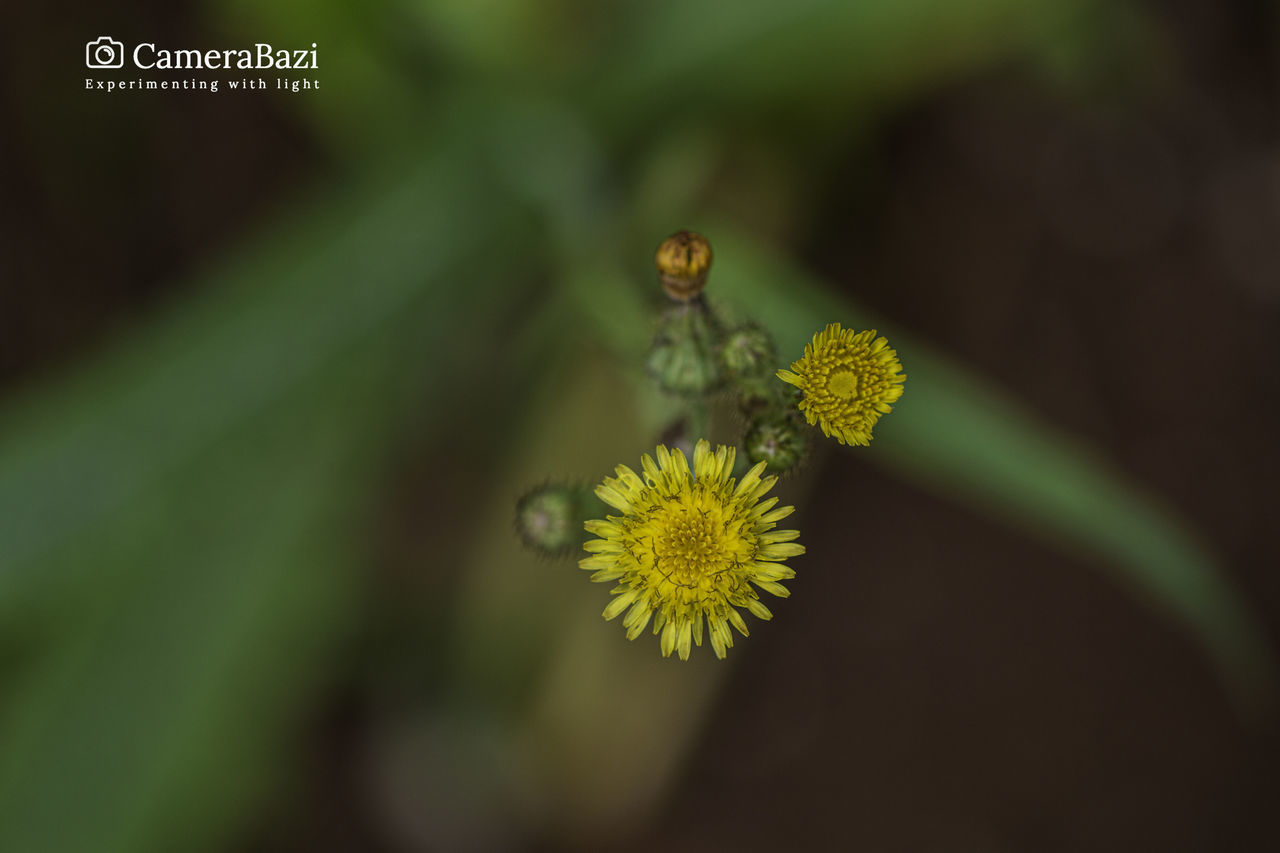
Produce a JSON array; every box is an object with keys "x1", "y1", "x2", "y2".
[{"x1": 0, "y1": 140, "x2": 536, "y2": 852}]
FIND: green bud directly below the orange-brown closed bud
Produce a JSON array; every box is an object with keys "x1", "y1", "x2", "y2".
[{"x1": 648, "y1": 300, "x2": 721, "y2": 396}]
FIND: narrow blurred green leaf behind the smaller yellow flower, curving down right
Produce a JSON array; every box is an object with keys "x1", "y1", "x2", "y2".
[{"x1": 710, "y1": 224, "x2": 1276, "y2": 713}]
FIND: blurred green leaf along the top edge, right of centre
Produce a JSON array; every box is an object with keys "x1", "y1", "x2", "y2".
[{"x1": 590, "y1": 0, "x2": 1092, "y2": 132}]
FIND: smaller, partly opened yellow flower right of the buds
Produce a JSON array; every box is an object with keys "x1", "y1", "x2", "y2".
[{"x1": 778, "y1": 323, "x2": 906, "y2": 444}]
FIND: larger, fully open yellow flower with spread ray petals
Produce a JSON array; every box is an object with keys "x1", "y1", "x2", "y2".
[{"x1": 579, "y1": 441, "x2": 804, "y2": 661}]
